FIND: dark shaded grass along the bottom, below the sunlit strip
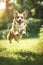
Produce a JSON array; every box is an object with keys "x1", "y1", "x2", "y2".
[{"x1": 0, "y1": 51, "x2": 43, "y2": 65}]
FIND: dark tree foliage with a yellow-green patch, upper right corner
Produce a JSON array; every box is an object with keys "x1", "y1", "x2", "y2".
[{"x1": 16, "y1": 0, "x2": 43, "y2": 19}]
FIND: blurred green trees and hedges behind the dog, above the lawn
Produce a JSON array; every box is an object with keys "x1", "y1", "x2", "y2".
[{"x1": 0, "y1": 0, "x2": 43, "y2": 39}]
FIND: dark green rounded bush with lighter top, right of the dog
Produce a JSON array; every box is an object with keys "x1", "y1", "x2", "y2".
[{"x1": 27, "y1": 18, "x2": 41, "y2": 36}]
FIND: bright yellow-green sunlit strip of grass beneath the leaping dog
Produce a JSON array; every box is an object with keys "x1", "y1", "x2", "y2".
[{"x1": 0, "y1": 39, "x2": 38, "y2": 52}]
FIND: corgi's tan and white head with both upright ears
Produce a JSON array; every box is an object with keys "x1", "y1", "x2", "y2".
[{"x1": 13, "y1": 9, "x2": 28, "y2": 24}]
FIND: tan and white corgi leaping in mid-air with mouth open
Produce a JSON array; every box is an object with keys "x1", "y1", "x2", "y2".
[{"x1": 7, "y1": 9, "x2": 28, "y2": 43}]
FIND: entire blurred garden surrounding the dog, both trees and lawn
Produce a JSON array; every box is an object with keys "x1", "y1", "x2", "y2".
[{"x1": 0, "y1": 0, "x2": 43, "y2": 65}]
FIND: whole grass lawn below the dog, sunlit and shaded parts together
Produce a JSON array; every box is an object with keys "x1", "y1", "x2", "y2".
[{"x1": 0, "y1": 38, "x2": 43, "y2": 65}]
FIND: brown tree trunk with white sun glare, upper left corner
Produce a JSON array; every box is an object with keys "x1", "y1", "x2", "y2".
[{"x1": 0, "y1": 0, "x2": 10, "y2": 18}]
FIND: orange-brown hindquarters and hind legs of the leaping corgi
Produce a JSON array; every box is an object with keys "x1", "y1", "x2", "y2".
[{"x1": 7, "y1": 29, "x2": 22, "y2": 43}]
